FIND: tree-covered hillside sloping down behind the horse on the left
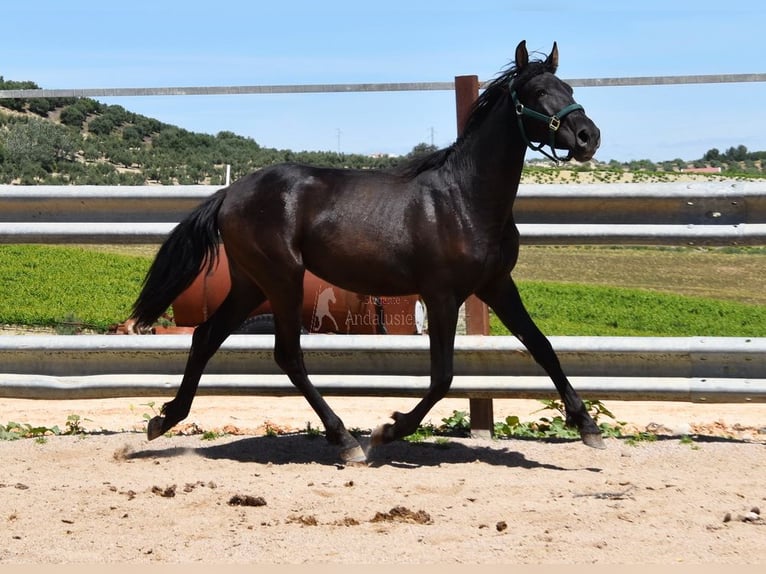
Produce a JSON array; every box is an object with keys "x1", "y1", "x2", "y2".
[{"x1": 0, "y1": 76, "x2": 408, "y2": 185}]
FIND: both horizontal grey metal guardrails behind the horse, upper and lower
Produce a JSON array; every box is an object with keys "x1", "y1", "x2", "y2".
[{"x1": 0, "y1": 181, "x2": 766, "y2": 432}]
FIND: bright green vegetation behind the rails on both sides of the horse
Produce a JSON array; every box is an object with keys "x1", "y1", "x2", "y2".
[{"x1": 0, "y1": 245, "x2": 766, "y2": 337}]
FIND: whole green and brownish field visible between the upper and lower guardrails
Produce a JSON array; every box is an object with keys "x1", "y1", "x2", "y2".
[{"x1": 0, "y1": 245, "x2": 766, "y2": 337}]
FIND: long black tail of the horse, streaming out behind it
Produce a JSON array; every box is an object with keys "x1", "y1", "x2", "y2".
[{"x1": 131, "y1": 188, "x2": 226, "y2": 327}]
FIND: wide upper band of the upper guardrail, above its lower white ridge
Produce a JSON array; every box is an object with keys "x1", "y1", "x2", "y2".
[{"x1": 0, "y1": 181, "x2": 766, "y2": 225}]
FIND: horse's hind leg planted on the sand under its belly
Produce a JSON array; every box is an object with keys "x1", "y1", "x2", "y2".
[{"x1": 269, "y1": 270, "x2": 367, "y2": 462}]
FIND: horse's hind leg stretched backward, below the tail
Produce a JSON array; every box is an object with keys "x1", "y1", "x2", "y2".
[{"x1": 147, "y1": 273, "x2": 266, "y2": 440}]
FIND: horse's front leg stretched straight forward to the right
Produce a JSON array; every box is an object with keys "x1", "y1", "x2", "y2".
[{"x1": 476, "y1": 275, "x2": 604, "y2": 448}]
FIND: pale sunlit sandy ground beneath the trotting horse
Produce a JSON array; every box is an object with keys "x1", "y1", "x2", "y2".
[{"x1": 0, "y1": 396, "x2": 766, "y2": 565}]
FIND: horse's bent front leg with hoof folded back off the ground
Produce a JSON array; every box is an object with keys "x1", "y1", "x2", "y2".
[{"x1": 371, "y1": 296, "x2": 460, "y2": 445}]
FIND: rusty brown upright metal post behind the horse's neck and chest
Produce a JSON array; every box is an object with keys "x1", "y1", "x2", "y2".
[{"x1": 455, "y1": 76, "x2": 494, "y2": 438}]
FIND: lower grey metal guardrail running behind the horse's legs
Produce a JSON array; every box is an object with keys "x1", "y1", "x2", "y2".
[{"x1": 0, "y1": 335, "x2": 766, "y2": 402}]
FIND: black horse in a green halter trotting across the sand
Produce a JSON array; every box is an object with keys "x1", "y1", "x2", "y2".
[{"x1": 132, "y1": 42, "x2": 603, "y2": 461}]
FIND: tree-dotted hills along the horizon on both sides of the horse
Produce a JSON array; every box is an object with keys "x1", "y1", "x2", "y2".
[{"x1": 0, "y1": 76, "x2": 766, "y2": 185}]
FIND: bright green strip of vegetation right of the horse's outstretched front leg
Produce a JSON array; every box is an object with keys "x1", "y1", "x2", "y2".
[{"x1": 490, "y1": 282, "x2": 766, "y2": 337}]
